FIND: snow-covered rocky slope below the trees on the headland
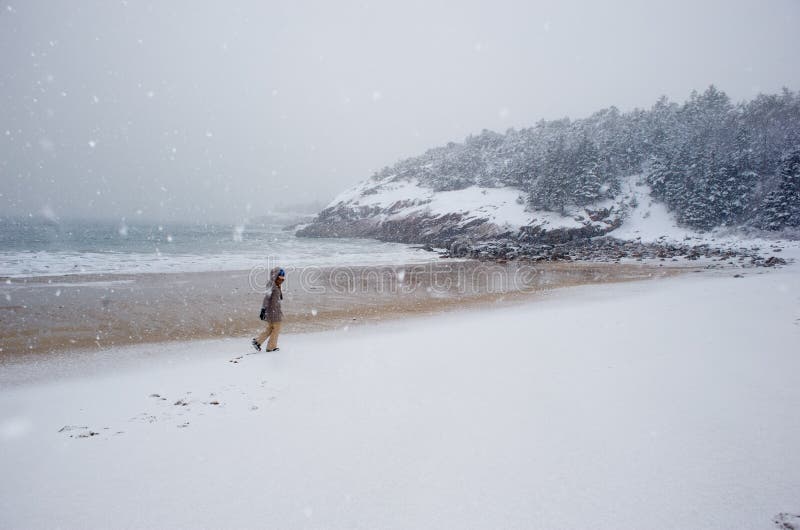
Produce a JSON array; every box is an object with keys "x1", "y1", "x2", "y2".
[{"x1": 299, "y1": 175, "x2": 698, "y2": 246}]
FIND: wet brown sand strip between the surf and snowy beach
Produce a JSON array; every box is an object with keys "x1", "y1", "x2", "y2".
[{"x1": 0, "y1": 260, "x2": 691, "y2": 356}]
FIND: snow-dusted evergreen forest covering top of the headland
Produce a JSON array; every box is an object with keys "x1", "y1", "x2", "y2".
[{"x1": 376, "y1": 86, "x2": 800, "y2": 230}]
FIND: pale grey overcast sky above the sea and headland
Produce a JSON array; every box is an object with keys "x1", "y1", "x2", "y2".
[{"x1": 0, "y1": 0, "x2": 800, "y2": 222}]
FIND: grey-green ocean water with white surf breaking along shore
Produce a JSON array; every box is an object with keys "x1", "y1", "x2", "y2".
[{"x1": 0, "y1": 219, "x2": 437, "y2": 278}]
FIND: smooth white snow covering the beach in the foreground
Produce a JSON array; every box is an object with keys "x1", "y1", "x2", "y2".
[{"x1": 0, "y1": 255, "x2": 800, "y2": 530}]
